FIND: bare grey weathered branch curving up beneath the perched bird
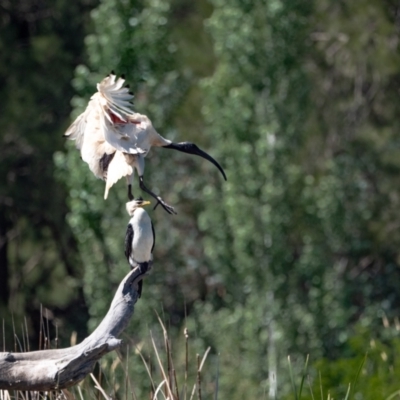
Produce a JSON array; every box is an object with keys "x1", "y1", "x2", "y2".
[{"x1": 0, "y1": 268, "x2": 145, "y2": 391}]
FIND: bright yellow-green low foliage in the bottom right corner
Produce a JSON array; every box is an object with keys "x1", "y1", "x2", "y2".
[{"x1": 302, "y1": 326, "x2": 400, "y2": 400}]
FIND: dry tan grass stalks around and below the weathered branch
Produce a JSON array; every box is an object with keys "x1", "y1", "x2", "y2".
[{"x1": 0, "y1": 312, "x2": 212, "y2": 400}]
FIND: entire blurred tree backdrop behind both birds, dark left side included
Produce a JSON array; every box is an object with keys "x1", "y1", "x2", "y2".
[{"x1": 5, "y1": 0, "x2": 400, "y2": 399}]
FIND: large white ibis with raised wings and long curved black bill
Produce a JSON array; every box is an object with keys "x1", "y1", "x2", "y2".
[{"x1": 64, "y1": 73, "x2": 226, "y2": 214}]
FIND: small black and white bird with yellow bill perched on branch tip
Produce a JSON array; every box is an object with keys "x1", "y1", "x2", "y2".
[{"x1": 125, "y1": 199, "x2": 156, "y2": 297}]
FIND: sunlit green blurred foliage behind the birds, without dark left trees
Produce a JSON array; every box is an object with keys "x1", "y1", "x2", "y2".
[{"x1": 56, "y1": 0, "x2": 399, "y2": 398}]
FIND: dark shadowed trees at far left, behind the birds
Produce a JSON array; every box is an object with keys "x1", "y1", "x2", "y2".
[{"x1": 0, "y1": 0, "x2": 96, "y2": 343}]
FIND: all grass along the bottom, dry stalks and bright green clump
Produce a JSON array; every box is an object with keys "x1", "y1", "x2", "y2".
[{"x1": 0, "y1": 313, "x2": 400, "y2": 400}]
